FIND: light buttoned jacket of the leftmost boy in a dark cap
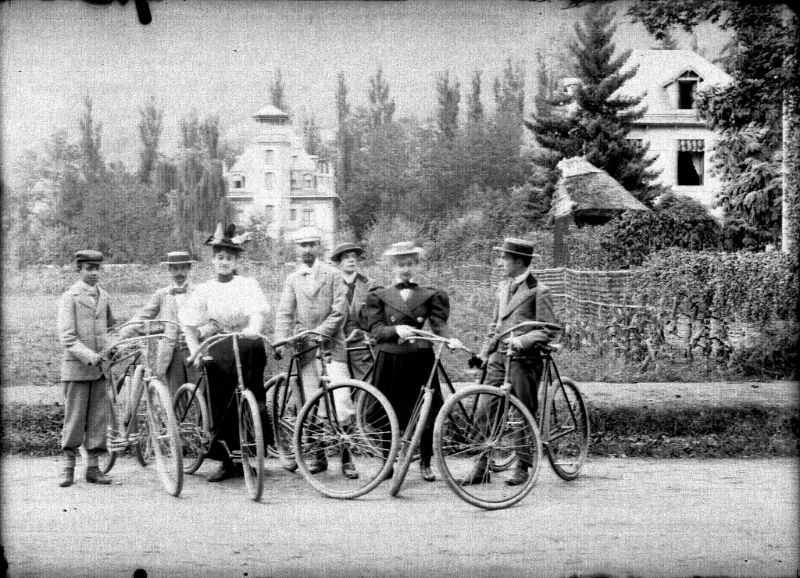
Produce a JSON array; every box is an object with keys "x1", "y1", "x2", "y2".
[{"x1": 58, "y1": 281, "x2": 116, "y2": 381}]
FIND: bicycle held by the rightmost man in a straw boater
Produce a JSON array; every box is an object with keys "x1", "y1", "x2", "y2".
[{"x1": 434, "y1": 321, "x2": 590, "y2": 509}]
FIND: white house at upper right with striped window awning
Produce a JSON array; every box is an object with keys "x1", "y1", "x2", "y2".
[{"x1": 619, "y1": 50, "x2": 732, "y2": 217}]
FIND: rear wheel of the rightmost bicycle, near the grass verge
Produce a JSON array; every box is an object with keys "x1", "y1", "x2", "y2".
[{"x1": 542, "y1": 378, "x2": 589, "y2": 481}]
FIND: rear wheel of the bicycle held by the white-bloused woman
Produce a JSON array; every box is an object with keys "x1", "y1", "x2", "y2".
[{"x1": 172, "y1": 383, "x2": 211, "y2": 474}]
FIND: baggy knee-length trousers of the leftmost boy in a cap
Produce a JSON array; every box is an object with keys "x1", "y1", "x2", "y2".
[{"x1": 61, "y1": 377, "x2": 109, "y2": 467}]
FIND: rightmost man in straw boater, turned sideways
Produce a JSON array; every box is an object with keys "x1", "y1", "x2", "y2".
[{"x1": 461, "y1": 238, "x2": 557, "y2": 486}]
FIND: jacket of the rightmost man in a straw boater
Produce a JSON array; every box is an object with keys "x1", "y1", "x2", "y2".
[{"x1": 481, "y1": 273, "x2": 558, "y2": 356}]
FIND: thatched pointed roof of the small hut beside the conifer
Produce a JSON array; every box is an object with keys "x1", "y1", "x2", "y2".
[{"x1": 550, "y1": 157, "x2": 650, "y2": 223}]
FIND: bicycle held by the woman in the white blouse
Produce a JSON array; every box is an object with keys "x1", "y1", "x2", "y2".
[{"x1": 173, "y1": 332, "x2": 271, "y2": 501}]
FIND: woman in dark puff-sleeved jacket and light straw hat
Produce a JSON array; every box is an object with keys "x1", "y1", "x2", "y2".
[{"x1": 364, "y1": 242, "x2": 461, "y2": 482}]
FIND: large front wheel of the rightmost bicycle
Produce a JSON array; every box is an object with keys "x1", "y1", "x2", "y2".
[{"x1": 433, "y1": 385, "x2": 542, "y2": 510}]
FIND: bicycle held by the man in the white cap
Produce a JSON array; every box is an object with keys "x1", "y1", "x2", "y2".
[{"x1": 266, "y1": 330, "x2": 398, "y2": 499}]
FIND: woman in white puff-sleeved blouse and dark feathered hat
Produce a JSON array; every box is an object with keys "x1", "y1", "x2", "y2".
[{"x1": 179, "y1": 224, "x2": 269, "y2": 482}]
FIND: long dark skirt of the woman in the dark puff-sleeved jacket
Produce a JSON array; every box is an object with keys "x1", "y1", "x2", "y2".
[{"x1": 372, "y1": 349, "x2": 442, "y2": 461}]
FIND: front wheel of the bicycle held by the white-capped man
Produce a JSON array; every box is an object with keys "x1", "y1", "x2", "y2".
[{"x1": 294, "y1": 379, "x2": 398, "y2": 499}]
